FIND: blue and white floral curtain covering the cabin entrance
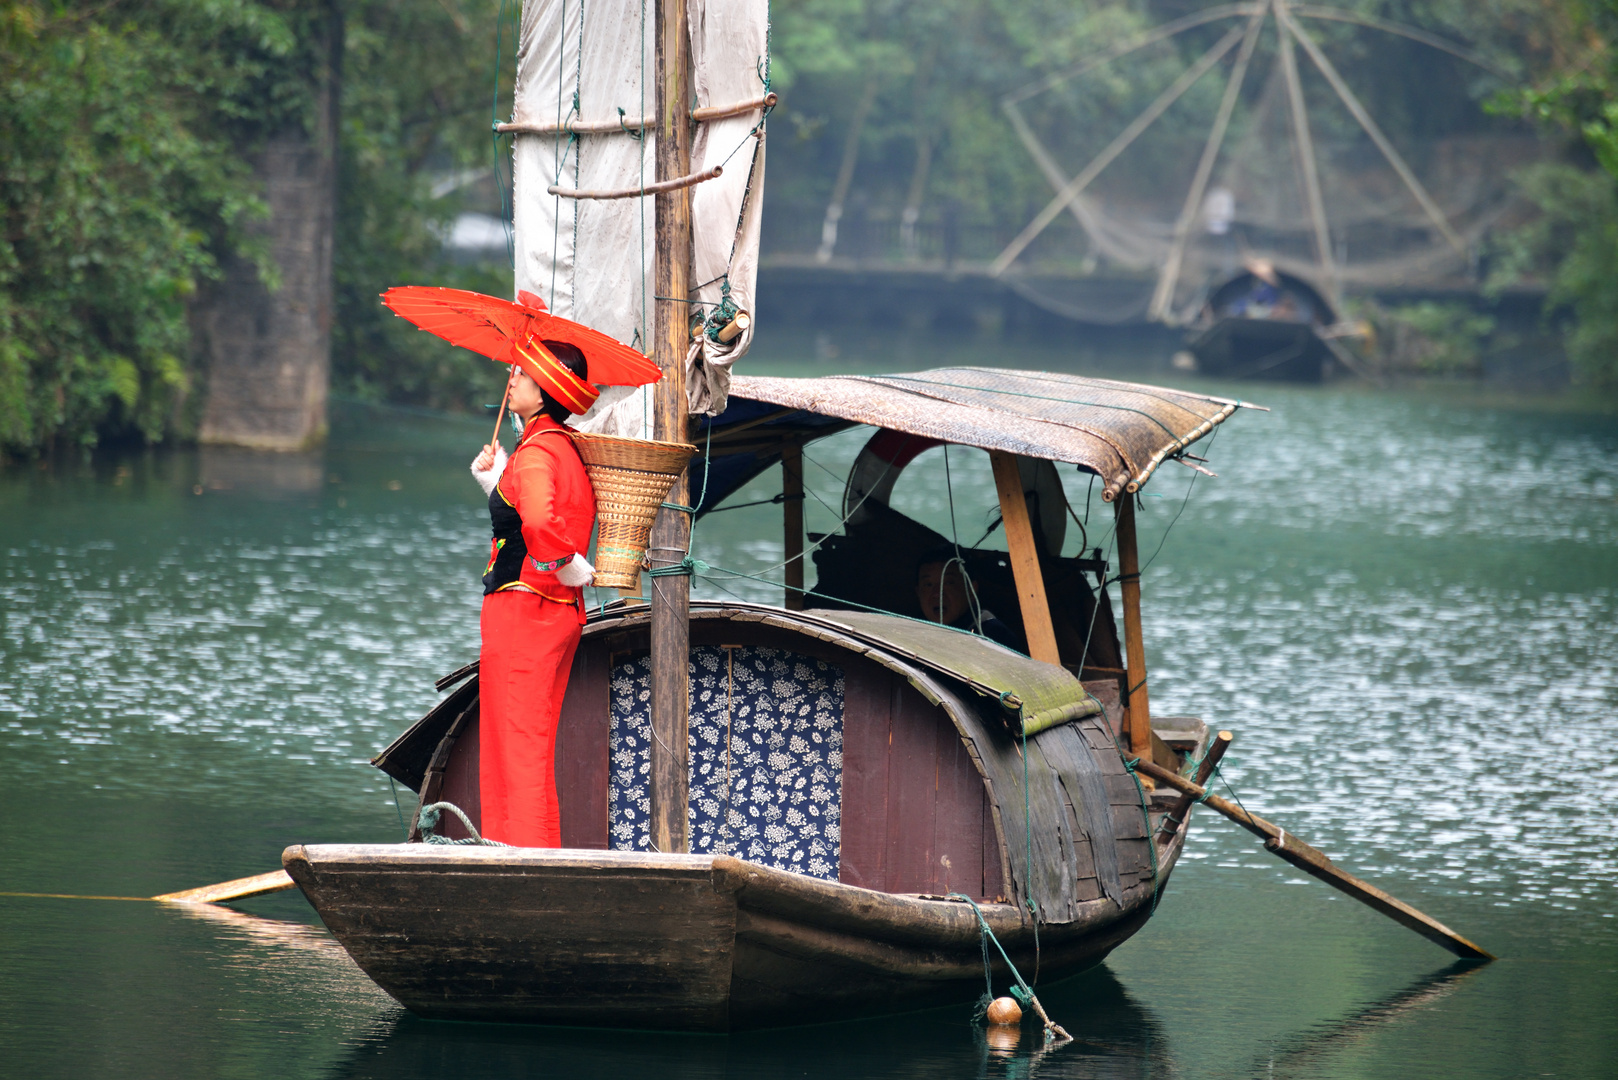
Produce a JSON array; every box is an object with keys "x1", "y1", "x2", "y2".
[{"x1": 607, "y1": 646, "x2": 843, "y2": 881}]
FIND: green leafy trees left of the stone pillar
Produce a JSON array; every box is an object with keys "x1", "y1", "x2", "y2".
[{"x1": 0, "y1": 0, "x2": 301, "y2": 449}]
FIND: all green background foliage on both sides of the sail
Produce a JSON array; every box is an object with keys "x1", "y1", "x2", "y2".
[{"x1": 0, "y1": 0, "x2": 1618, "y2": 453}]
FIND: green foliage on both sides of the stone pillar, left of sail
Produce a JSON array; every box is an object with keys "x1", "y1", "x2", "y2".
[{"x1": 0, "y1": 0, "x2": 503, "y2": 452}]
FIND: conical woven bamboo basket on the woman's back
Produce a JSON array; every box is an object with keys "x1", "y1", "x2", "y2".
[{"x1": 573, "y1": 431, "x2": 697, "y2": 589}]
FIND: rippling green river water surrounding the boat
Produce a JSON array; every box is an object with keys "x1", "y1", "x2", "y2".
[{"x1": 0, "y1": 348, "x2": 1618, "y2": 1080}]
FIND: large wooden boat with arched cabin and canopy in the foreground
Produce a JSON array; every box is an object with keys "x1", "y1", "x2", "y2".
[{"x1": 283, "y1": 368, "x2": 1236, "y2": 1031}]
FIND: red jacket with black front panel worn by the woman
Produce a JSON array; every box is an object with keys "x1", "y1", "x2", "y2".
[{"x1": 484, "y1": 415, "x2": 595, "y2": 610}]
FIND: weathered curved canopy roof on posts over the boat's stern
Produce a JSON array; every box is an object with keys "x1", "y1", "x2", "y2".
[{"x1": 693, "y1": 368, "x2": 1239, "y2": 508}]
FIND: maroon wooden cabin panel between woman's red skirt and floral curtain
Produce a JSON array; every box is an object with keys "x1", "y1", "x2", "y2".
[{"x1": 557, "y1": 641, "x2": 612, "y2": 852}]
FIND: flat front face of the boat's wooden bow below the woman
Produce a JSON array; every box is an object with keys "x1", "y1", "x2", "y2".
[{"x1": 283, "y1": 844, "x2": 735, "y2": 1030}]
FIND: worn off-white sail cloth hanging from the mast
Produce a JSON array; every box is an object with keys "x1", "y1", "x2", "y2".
[{"x1": 513, "y1": 0, "x2": 769, "y2": 437}]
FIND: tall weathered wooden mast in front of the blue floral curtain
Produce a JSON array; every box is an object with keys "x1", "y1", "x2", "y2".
[{"x1": 647, "y1": 0, "x2": 693, "y2": 852}]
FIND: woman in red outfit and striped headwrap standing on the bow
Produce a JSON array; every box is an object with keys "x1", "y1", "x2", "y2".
[{"x1": 472, "y1": 340, "x2": 599, "y2": 847}]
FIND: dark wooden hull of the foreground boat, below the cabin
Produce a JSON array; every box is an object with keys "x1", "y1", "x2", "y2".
[{"x1": 283, "y1": 840, "x2": 1178, "y2": 1031}]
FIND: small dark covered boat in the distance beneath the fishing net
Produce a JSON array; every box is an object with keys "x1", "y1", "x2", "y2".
[{"x1": 1189, "y1": 270, "x2": 1356, "y2": 382}]
